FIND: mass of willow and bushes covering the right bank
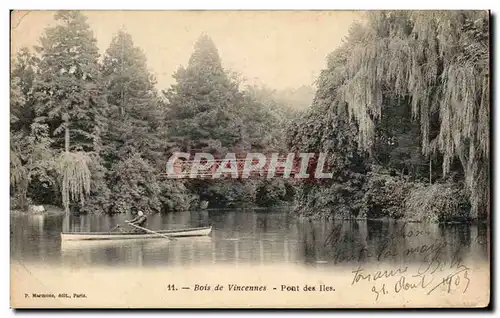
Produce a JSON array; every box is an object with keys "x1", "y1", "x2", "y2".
[{"x1": 290, "y1": 11, "x2": 490, "y2": 220}]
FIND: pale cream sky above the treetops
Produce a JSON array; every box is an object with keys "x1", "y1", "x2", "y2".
[{"x1": 11, "y1": 11, "x2": 362, "y2": 89}]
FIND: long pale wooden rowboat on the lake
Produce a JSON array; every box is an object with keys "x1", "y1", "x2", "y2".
[{"x1": 61, "y1": 226, "x2": 212, "y2": 241}]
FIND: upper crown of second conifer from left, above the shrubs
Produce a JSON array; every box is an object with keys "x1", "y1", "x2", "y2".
[{"x1": 102, "y1": 30, "x2": 164, "y2": 167}]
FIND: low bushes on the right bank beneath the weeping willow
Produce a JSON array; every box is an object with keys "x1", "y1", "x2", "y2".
[{"x1": 295, "y1": 163, "x2": 471, "y2": 222}]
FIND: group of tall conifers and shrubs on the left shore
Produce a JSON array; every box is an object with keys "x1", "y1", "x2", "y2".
[{"x1": 11, "y1": 11, "x2": 295, "y2": 213}]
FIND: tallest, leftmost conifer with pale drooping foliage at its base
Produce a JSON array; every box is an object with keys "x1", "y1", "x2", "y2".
[{"x1": 34, "y1": 11, "x2": 106, "y2": 212}]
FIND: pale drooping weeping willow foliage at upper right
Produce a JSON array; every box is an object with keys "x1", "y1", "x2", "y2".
[{"x1": 331, "y1": 11, "x2": 490, "y2": 217}]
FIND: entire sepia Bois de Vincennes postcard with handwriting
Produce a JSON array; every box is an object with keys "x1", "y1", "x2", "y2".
[{"x1": 8, "y1": 10, "x2": 492, "y2": 309}]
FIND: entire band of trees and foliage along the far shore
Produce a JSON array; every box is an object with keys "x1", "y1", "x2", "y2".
[{"x1": 10, "y1": 11, "x2": 490, "y2": 221}]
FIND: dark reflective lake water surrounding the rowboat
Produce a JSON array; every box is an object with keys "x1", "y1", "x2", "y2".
[{"x1": 11, "y1": 210, "x2": 489, "y2": 269}]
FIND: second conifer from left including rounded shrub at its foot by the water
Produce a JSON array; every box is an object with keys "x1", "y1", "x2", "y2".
[{"x1": 102, "y1": 30, "x2": 173, "y2": 213}]
